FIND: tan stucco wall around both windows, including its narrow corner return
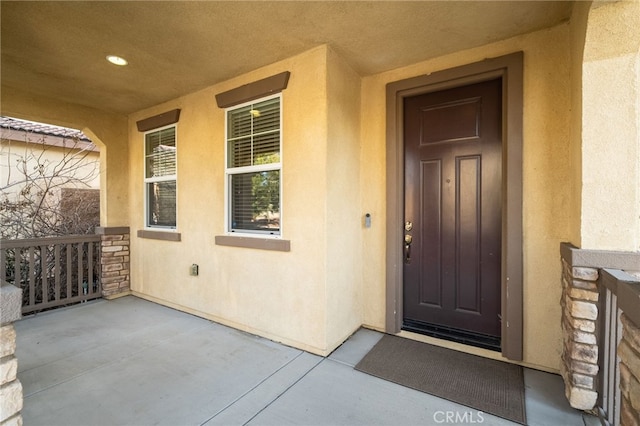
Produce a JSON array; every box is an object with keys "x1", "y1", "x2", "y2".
[{"x1": 129, "y1": 47, "x2": 362, "y2": 354}]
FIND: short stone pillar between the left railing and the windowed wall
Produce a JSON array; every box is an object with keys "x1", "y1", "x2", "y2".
[{"x1": 96, "y1": 226, "x2": 131, "y2": 298}]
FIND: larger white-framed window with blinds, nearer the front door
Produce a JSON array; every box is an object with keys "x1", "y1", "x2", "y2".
[{"x1": 226, "y1": 95, "x2": 281, "y2": 235}]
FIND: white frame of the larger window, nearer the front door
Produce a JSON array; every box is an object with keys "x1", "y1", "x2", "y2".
[{"x1": 224, "y1": 93, "x2": 283, "y2": 239}]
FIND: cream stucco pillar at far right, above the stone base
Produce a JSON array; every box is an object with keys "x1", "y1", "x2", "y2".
[{"x1": 579, "y1": 1, "x2": 640, "y2": 251}]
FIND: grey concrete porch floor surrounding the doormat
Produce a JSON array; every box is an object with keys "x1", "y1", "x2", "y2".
[{"x1": 15, "y1": 296, "x2": 598, "y2": 426}]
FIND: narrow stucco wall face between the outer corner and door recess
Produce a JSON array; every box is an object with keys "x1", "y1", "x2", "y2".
[{"x1": 325, "y1": 50, "x2": 366, "y2": 346}]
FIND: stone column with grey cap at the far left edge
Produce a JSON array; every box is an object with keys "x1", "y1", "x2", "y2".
[{"x1": 0, "y1": 282, "x2": 24, "y2": 426}]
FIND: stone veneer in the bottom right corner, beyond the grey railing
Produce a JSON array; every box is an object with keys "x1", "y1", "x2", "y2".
[{"x1": 618, "y1": 313, "x2": 640, "y2": 426}]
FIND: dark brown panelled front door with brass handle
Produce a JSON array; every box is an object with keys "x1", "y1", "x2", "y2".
[{"x1": 403, "y1": 79, "x2": 502, "y2": 349}]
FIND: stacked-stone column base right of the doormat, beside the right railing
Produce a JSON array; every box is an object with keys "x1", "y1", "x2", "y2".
[{"x1": 560, "y1": 259, "x2": 599, "y2": 410}]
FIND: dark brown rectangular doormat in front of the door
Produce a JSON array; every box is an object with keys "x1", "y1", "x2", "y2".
[{"x1": 355, "y1": 334, "x2": 526, "y2": 424}]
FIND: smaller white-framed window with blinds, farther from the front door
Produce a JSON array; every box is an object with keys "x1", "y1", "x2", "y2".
[{"x1": 144, "y1": 125, "x2": 177, "y2": 229}]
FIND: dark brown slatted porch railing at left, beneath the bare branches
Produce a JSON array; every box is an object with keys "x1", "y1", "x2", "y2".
[{"x1": 0, "y1": 235, "x2": 102, "y2": 314}]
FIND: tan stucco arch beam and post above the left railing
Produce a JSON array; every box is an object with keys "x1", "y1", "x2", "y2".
[{"x1": 1, "y1": 87, "x2": 129, "y2": 226}]
